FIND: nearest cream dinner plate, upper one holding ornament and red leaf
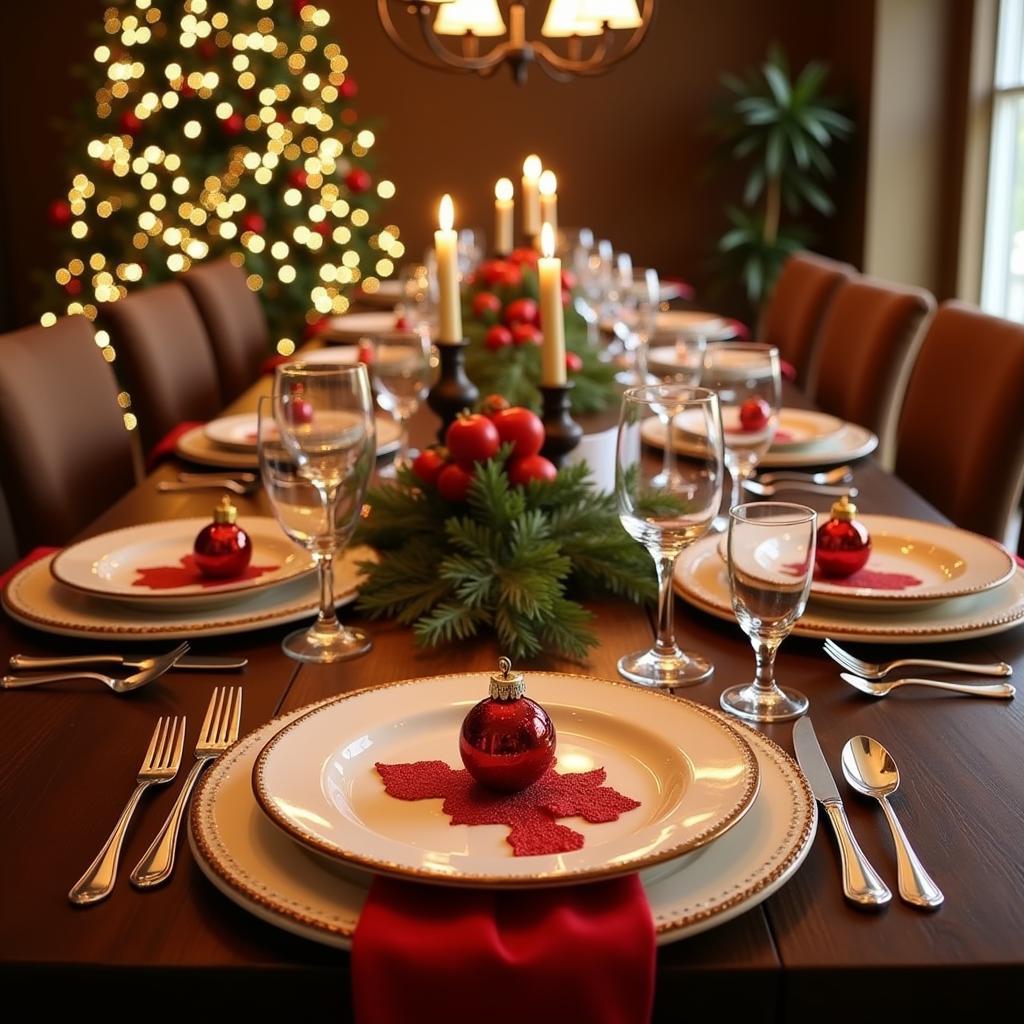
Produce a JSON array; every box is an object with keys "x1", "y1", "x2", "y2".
[{"x1": 253, "y1": 673, "x2": 758, "y2": 888}]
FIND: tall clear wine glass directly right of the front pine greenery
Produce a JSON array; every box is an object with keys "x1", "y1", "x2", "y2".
[{"x1": 615, "y1": 384, "x2": 724, "y2": 688}]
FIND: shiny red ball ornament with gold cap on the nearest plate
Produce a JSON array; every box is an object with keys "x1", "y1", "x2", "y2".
[{"x1": 459, "y1": 657, "x2": 555, "y2": 793}]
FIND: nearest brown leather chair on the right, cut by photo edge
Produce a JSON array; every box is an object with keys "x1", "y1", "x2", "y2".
[{"x1": 896, "y1": 302, "x2": 1024, "y2": 541}]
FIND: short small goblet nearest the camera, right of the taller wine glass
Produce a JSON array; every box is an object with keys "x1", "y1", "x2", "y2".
[{"x1": 720, "y1": 502, "x2": 817, "y2": 722}]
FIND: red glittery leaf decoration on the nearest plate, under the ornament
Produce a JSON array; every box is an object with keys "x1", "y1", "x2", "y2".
[{"x1": 377, "y1": 761, "x2": 640, "y2": 857}]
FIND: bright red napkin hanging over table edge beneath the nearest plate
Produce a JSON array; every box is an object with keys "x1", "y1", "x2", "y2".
[{"x1": 352, "y1": 874, "x2": 654, "y2": 1024}]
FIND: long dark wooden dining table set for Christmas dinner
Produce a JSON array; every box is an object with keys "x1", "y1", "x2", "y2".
[{"x1": 0, "y1": 364, "x2": 1024, "y2": 1024}]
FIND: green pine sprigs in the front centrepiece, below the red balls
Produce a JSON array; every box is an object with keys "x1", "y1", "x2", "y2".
[{"x1": 356, "y1": 447, "x2": 656, "y2": 660}]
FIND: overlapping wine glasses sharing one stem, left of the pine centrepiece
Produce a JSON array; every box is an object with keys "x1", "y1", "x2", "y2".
[{"x1": 258, "y1": 362, "x2": 377, "y2": 664}]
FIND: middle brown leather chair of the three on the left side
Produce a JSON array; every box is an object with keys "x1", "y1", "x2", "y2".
[{"x1": 102, "y1": 282, "x2": 223, "y2": 452}]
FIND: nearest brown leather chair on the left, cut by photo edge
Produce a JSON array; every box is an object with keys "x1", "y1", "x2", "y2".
[{"x1": 0, "y1": 316, "x2": 135, "y2": 554}]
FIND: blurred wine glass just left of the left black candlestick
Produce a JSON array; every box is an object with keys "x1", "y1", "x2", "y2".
[{"x1": 360, "y1": 331, "x2": 430, "y2": 479}]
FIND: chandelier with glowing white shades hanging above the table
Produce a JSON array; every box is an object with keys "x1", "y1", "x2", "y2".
[{"x1": 377, "y1": 0, "x2": 654, "y2": 85}]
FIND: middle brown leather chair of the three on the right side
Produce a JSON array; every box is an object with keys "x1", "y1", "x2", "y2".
[{"x1": 812, "y1": 278, "x2": 935, "y2": 467}]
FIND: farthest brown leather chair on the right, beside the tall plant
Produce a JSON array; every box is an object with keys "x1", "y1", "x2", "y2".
[{"x1": 758, "y1": 252, "x2": 857, "y2": 385}]
